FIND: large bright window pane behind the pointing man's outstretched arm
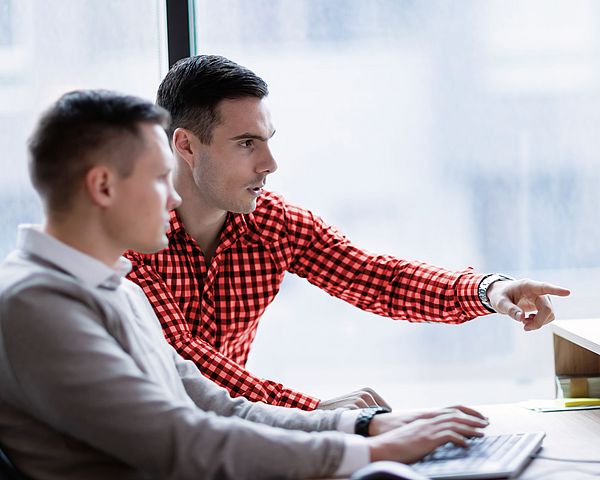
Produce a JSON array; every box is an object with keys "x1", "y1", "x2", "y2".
[{"x1": 195, "y1": 0, "x2": 600, "y2": 406}]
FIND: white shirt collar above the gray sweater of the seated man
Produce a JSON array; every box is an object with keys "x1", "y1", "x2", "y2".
[{"x1": 17, "y1": 225, "x2": 131, "y2": 289}]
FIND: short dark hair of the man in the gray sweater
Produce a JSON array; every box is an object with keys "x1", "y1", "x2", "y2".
[{"x1": 29, "y1": 90, "x2": 170, "y2": 212}]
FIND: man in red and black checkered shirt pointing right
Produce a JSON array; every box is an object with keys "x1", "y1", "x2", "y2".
[{"x1": 128, "y1": 55, "x2": 569, "y2": 410}]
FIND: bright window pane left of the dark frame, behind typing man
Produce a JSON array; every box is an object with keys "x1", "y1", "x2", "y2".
[{"x1": 0, "y1": 0, "x2": 167, "y2": 257}]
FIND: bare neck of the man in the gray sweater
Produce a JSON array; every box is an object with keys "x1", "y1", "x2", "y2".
[{"x1": 43, "y1": 215, "x2": 123, "y2": 268}]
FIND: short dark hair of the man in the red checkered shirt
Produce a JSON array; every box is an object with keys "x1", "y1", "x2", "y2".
[{"x1": 156, "y1": 55, "x2": 269, "y2": 145}]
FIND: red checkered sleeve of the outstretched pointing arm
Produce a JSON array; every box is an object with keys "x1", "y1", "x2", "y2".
[{"x1": 284, "y1": 204, "x2": 489, "y2": 323}]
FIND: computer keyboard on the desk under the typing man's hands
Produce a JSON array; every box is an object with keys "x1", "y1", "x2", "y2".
[{"x1": 412, "y1": 432, "x2": 545, "y2": 480}]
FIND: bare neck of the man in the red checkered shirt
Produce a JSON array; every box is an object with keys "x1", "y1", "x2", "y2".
[{"x1": 173, "y1": 163, "x2": 227, "y2": 262}]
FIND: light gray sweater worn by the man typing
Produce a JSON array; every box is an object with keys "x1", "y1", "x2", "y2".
[{"x1": 0, "y1": 242, "x2": 344, "y2": 480}]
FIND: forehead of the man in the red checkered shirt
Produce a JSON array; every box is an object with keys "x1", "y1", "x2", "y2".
[{"x1": 217, "y1": 97, "x2": 273, "y2": 136}]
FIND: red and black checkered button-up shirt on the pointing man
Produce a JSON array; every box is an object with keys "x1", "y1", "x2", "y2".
[{"x1": 127, "y1": 192, "x2": 489, "y2": 410}]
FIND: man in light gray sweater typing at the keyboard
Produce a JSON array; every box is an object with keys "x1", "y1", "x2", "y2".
[{"x1": 0, "y1": 91, "x2": 487, "y2": 480}]
